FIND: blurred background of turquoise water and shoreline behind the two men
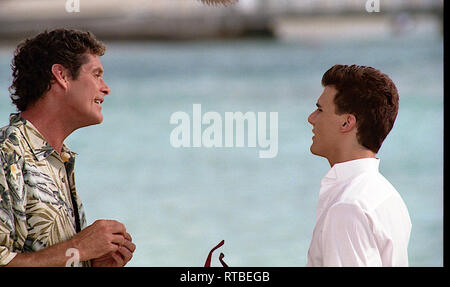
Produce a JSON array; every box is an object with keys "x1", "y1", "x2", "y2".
[{"x1": 0, "y1": 0, "x2": 443, "y2": 267}]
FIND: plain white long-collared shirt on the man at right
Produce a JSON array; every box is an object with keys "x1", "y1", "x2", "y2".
[{"x1": 307, "y1": 158, "x2": 411, "y2": 267}]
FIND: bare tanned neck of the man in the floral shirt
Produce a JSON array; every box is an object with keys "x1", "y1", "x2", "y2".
[{"x1": 21, "y1": 108, "x2": 74, "y2": 154}]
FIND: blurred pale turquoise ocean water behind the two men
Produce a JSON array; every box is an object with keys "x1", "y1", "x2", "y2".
[{"x1": 0, "y1": 35, "x2": 443, "y2": 266}]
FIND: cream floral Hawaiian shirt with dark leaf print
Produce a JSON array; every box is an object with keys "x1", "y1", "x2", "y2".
[{"x1": 0, "y1": 114, "x2": 89, "y2": 266}]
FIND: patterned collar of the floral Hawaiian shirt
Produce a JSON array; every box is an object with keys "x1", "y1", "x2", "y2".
[{"x1": 9, "y1": 113, "x2": 76, "y2": 161}]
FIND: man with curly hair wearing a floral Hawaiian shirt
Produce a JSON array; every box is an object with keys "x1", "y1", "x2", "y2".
[{"x1": 0, "y1": 29, "x2": 136, "y2": 266}]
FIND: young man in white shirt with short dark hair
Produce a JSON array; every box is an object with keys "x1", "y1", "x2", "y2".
[{"x1": 307, "y1": 65, "x2": 411, "y2": 267}]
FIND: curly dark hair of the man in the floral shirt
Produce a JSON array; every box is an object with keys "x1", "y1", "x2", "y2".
[{"x1": 9, "y1": 29, "x2": 106, "y2": 111}]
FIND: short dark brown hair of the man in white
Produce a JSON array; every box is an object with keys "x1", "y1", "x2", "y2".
[{"x1": 322, "y1": 65, "x2": 399, "y2": 153}]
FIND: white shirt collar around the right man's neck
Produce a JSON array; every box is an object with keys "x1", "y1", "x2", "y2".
[{"x1": 322, "y1": 158, "x2": 380, "y2": 183}]
